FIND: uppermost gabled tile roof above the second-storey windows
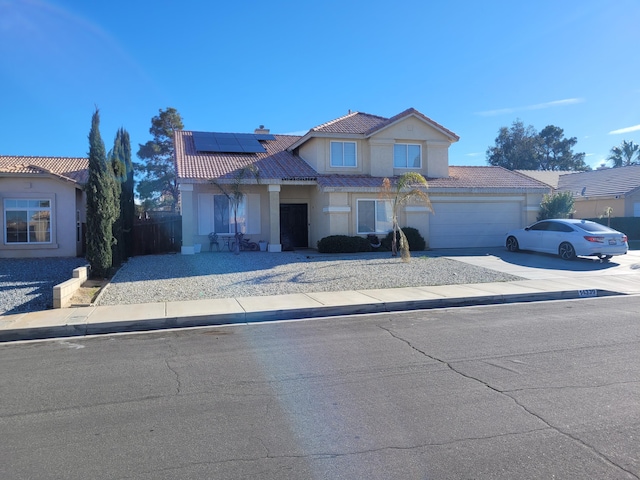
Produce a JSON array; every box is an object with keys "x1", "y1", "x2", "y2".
[{"x1": 309, "y1": 108, "x2": 460, "y2": 141}]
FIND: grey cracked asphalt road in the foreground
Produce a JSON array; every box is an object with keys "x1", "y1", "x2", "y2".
[{"x1": 0, "y1": 297, "x2": 640, "y2": 480}]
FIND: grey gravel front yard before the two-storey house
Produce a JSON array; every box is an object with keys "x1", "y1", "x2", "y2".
[{"x1": 96, "y1": 251, "x2": 521, "y2": 305}]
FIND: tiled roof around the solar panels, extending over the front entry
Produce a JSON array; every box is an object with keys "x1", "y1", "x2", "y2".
[{"x1": 174, "y1": 130, "x2": 317, "y2": 181}]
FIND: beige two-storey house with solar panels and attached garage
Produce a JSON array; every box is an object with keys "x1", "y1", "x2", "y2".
[{"x1": 174, "y1": 108, "x2": 551, "y2": 254}]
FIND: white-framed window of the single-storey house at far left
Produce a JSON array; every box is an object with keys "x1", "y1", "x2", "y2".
[{"x1": 4, "y1": 198, "x2": 51, "y2": 243}]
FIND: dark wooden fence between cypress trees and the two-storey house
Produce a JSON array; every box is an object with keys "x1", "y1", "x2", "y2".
[{"x1": 133, "y1": 215, "x2": 182, "y2": 256}]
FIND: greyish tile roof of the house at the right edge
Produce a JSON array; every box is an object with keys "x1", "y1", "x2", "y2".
[{"x1": 558, "y1": 165, "x2": 640, "y2": 198}]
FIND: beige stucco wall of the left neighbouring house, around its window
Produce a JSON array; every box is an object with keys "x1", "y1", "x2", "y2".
[{"x1": 0, "y1": 176, "x2": 86, "y2": 258}]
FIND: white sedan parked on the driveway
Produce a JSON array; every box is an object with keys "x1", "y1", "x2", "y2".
[{"x1": 506, "y1": 219, "x2": 629, "y2": 260}]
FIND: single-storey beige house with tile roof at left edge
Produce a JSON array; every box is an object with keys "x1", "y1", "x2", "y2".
[{"x1": 0, "y1": 155, "x2": 89, "y2": 258}]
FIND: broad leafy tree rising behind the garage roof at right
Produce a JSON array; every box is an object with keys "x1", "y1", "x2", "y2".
[{"x1": 487, "y1": 120, "x2": 590, "y2": 171}]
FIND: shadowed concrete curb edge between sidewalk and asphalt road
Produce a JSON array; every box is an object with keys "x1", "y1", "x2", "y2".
[{"x1": 0, "y1": 289, "x2": 626, "y2": 343}]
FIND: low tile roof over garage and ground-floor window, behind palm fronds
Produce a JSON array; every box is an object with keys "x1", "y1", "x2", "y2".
[{"x1": 318, "y1": 166, "x2": 549, "y2": 191}]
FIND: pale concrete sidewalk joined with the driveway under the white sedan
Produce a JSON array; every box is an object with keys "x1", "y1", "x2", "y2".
[{"x1": 0, "y1": 249, "x2": 640, "y2": 342}]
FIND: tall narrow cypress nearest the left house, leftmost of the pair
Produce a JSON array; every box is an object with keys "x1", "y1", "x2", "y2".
[{"x1": 86, "y1": 108, "x2": 117, "y2": 278}]
